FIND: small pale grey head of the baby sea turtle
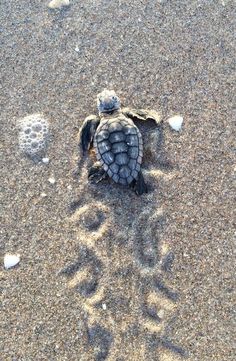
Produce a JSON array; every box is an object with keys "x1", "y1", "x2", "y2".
[{"x1": 97, "y1": 89, "x2": 120, "y2": 113}]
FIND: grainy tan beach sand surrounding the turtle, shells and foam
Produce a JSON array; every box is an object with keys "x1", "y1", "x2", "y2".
[{"x1": 0, "y1": 0, "x2": 235, "y2": 361}]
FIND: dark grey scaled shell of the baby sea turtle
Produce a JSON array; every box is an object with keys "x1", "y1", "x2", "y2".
[{"x1": 94, "y1": 114, "x2": 143, "y2": 185}]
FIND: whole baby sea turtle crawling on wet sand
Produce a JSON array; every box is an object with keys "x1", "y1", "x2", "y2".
[{"x1": 80, "y1": 89, "x2": 160, "y2": 195}]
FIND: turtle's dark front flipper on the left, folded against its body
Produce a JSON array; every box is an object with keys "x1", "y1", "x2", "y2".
[{"x1": 80, "y1": 115, "x2": 100, "y2": 154}]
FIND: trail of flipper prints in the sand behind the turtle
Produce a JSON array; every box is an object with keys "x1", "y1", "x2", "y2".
[{"x1": 59, "y1": 120, "x2": 186, "y2": 361}]
